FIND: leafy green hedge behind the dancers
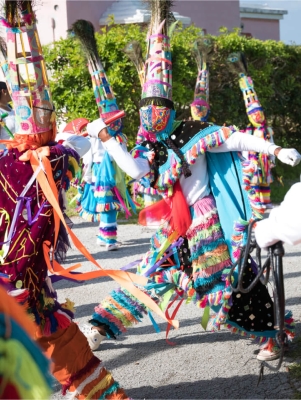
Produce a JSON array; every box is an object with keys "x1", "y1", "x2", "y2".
[{"x1": 45, "y1": 21, "x2": 301, "y2": 149}]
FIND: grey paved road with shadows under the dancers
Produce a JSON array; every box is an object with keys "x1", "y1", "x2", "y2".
[{"x1": 52, "y1": 218, "x2": 301, "y2": 399}]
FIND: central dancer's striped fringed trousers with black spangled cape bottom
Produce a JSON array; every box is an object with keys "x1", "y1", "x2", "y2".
[{"x1": 138, "y1": 195, "x2": 293, "y2": 341}]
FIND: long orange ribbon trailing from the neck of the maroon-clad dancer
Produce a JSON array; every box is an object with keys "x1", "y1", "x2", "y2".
[{"x1": 20, "y1": 147, "x2": 179, "y2": 329}]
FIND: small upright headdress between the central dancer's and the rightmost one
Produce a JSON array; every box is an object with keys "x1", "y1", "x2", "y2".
[{"x1": 190, "y1": 37, "x2": 212, "y2": 121}]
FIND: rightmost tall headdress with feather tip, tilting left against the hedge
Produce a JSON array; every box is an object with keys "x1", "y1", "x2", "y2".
[{"x1": 227, "y1": 52, "x2": 265, "y2": 128}]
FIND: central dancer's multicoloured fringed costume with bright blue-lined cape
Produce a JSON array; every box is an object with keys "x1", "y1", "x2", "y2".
[{"x1": 86, "y1": 121, "x2": 293, "y2": 342}]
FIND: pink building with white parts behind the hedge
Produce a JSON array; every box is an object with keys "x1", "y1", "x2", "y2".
[{"x1": 37, "y1": 0, "x2": 287, "y2": 44}]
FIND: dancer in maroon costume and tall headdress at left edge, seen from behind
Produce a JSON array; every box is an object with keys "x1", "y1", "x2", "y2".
[{"x1": 0, "y1": 5, "x2": 126, "y2": 399}]
